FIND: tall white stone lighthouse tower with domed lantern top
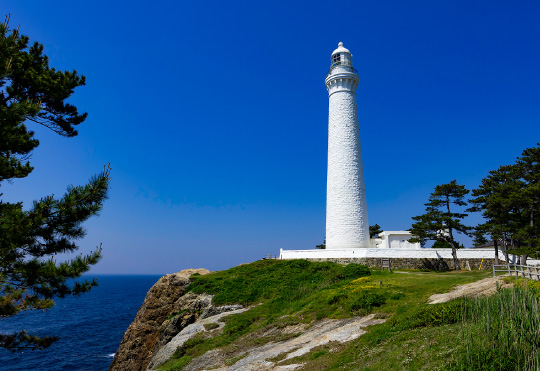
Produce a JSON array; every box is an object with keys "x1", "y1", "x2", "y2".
[{"x1": 325, "y1": 42, "x2": 370, "y2": 249}]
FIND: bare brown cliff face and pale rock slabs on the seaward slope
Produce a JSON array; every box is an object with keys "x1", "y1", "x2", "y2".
[{"x1": 109, "y1": 269, "x2": 386, "y2": 371}]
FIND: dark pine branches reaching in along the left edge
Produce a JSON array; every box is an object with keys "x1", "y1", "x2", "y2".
[{"x1": 0, "y1": 16, "x2": 110, "y2": 351}]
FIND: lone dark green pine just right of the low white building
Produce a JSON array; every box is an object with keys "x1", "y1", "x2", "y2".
[{"x1": 409, "y1": 179, "x2": 471, "y2": 270}]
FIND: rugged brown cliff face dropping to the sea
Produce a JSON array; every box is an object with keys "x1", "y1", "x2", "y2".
[{"x1": 109, "y1": 269, "x2": 212, "y2": 371}]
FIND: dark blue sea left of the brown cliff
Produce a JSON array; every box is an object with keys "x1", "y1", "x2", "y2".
[{"x1": 0, "y1": 275, "x2": 160, "y2": 371}]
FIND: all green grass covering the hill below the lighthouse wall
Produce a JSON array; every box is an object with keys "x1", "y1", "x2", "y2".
[{"x1": 160, "y1": 260, "x2": 540, "y2": 370}]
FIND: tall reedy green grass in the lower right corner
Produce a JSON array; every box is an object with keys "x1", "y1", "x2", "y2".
[{"x1": 446, "y1": 281, "x2": 540, "y2": 370}]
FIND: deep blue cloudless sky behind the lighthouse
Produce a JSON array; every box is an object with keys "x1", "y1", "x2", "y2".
[{"x1": 1, "y1": 0, "x2": 540, "y2": 274}]
